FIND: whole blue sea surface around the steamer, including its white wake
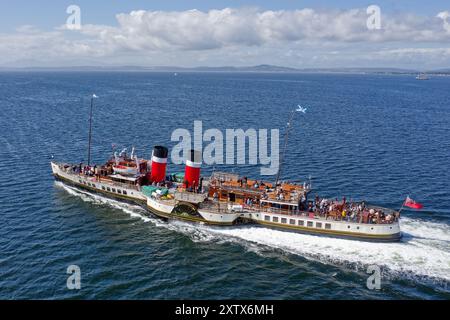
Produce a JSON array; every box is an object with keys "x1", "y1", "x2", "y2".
[{"x1": 0, "y1": 72, "x2": 450, "y2": 299}]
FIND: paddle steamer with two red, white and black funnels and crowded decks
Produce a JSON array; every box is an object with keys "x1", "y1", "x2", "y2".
[{"x1": 51, "y1": 96, "x2": 401, "y2": 241}]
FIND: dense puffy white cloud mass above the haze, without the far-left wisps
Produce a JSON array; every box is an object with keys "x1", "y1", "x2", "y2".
[{"x1": 94, "y1": 8, "x2": 450, "y2": 50}]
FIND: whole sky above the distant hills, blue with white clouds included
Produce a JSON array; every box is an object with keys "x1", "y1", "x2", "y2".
[{"x1": 0, "y1": 0, "x2": 450, "y2": 68}]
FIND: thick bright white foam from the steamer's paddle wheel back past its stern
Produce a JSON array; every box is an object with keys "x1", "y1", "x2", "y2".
[{"x1": 205, "y1": 218, "x2": 450, "y2": 281}]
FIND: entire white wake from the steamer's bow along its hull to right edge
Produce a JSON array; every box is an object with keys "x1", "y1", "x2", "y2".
[{"x1": 59, "y1": 183, "x2": 450, "y2": 282}]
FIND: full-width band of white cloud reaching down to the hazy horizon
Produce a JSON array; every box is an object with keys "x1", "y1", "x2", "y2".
[{"x1": 0, "y1": 8, "x2": 450, "y2": 64}]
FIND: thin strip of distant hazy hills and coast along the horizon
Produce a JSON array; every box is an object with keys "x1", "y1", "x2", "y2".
[{"x1": 0, "y1": 64, "x2": 450, "y2": 76}]
